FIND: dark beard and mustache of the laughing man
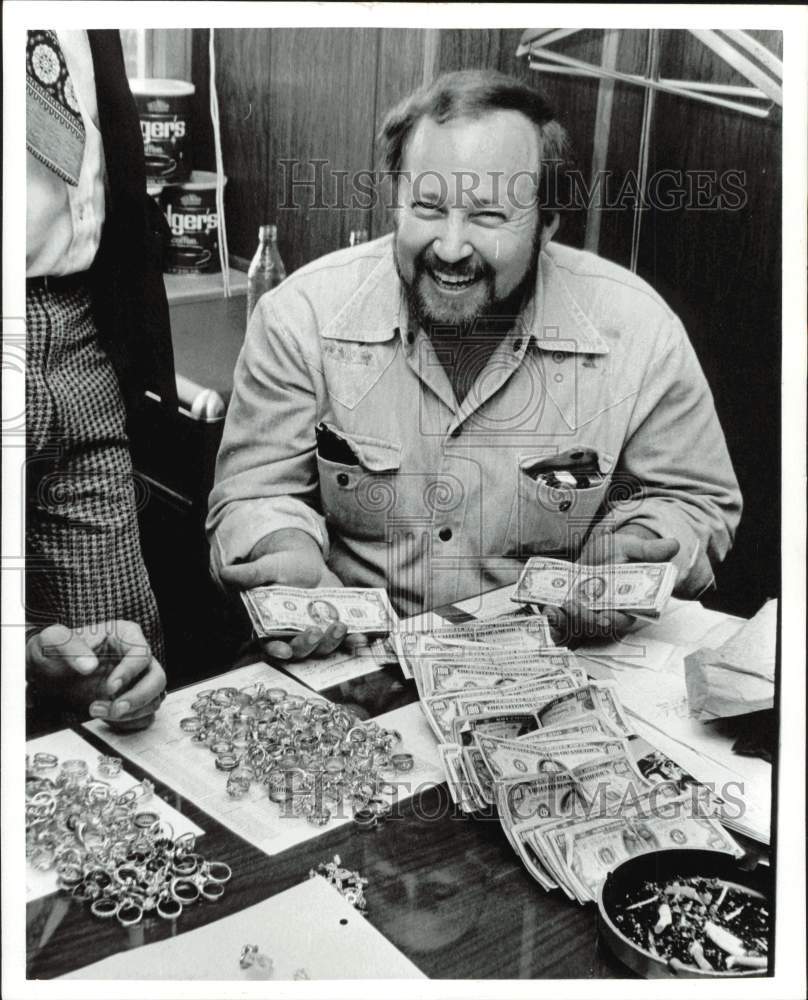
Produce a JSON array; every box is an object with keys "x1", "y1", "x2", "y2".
[{"x1": 393, "y1": 226, "x2": 541, "y2": 336}]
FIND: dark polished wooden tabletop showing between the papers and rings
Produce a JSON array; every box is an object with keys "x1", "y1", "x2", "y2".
[{"x1": 27, "y1": 592, "x2": 768, "y2": 979}]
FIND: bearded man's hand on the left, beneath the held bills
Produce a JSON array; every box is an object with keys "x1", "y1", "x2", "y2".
[{"x1": 219, "y1": 528, "x2": 363, "y2": 660}]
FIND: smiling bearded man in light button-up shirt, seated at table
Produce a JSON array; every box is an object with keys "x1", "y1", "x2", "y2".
[{"x1": 208, "y1": 71, "x2": 741, "y2": 658}]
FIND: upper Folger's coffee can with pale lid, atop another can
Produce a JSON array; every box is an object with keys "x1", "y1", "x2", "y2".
[{"x1": 129, "y1": 79, "x2": 194, "y2": 184}]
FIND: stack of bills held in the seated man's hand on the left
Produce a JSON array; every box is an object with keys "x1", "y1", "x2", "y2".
[{"x1": 241, "y1": 586, "x2": 398, "y2": 639}]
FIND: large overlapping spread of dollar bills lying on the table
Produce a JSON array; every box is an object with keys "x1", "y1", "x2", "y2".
[{"x1": 399, "y1": 615, "x2": 742, "y2": 903}]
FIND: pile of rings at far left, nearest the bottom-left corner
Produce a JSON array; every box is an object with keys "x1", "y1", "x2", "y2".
[{"x1": 25, "y1": 753, "x2": 231, "y2": 927}]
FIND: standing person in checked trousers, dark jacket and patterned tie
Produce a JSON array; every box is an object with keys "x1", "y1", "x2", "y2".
[{"x1": 26, "y1": 29, "x2": 176, "y2": 728}]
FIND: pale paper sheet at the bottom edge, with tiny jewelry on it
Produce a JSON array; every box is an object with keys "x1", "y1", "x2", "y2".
[{"x1": 62, "y1": 876, "x2": 426, "y2": 980}]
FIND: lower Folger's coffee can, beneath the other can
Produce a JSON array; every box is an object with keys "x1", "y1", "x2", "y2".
[{"x1": 160, "y1": 170, "x2": 227, "y2": 274}]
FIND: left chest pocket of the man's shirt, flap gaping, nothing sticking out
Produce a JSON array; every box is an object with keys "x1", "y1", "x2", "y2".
[{"x1": 317, "y1": 425, "x2": 401, "y2": 540}]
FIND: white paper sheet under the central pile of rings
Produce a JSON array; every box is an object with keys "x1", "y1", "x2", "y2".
[{"x1": 85, "y1": 663, "x2": 443, "y2": 854}]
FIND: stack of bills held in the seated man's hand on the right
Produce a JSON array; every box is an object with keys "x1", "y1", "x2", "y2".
[{"x1": 513, "y1": 556, "x2": 676, "y2": 619}]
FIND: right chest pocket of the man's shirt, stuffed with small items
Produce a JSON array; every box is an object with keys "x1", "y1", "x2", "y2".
[{"x1": 503, "y1": 454, "x2": 614, "y2": 559}]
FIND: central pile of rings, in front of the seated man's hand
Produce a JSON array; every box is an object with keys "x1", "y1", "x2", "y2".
[{"x1": 180, "y1": 683, "x2": 414, "y2": 828}]
